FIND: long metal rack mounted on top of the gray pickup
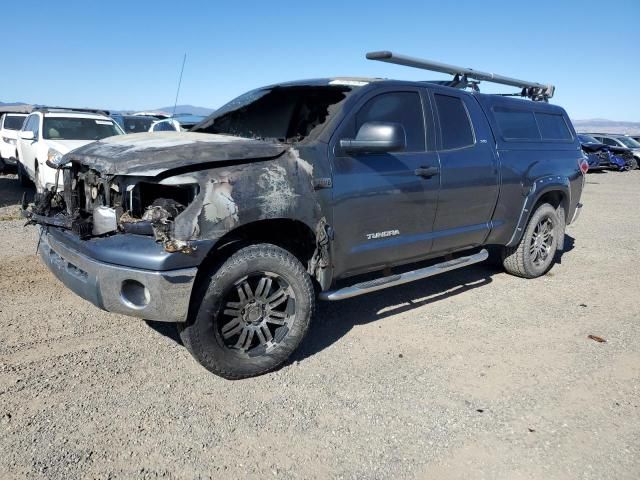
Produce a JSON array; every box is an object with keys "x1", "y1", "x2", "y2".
[{"x1": 367, "y1": 51, "x2": 556, "y2": 102}]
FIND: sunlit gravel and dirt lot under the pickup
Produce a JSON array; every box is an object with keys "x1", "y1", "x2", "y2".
[{"x1": 0, "y1": 171, "x2": 640, "y2": 480}]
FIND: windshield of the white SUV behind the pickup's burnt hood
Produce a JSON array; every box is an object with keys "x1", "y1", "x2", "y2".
[{"x1": 42, "y1": 117, "x2": 122, "y2": 140}]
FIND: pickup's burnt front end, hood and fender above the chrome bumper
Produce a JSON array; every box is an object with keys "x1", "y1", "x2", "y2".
[{"x1": 23, "y1": 128, "x2": 332, "y2": 296}]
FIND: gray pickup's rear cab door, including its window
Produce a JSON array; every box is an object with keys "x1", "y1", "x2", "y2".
[{"x1": 431, "y1": 90, "x2": 498, "y2": 253}]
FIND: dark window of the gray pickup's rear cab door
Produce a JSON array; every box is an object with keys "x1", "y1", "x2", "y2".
[{"x1": 433, "y1": 93, "x2": 475, "y2": 150}]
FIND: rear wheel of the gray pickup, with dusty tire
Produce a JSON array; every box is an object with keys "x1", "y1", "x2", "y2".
[{"x1": 502, "y1": 203, "x2": 565, "y2": 278}]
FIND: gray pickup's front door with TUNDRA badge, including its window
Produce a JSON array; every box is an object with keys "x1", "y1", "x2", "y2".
[{"x1": 329, "y1": 87, "x2": 439, "y2": 278}]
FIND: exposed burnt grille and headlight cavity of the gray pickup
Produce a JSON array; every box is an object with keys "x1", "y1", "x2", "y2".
[{"x1": 23, "y1": 162, "x2": 200, "y2": 254}]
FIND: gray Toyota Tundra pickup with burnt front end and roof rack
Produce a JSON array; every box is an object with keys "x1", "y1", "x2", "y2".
[{"x1": 24, "y1": 52, "x2": 588, "y2": 379}]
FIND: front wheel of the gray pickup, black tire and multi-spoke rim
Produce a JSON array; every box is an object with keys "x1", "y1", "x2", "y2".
[{"x1": 178, "y1": 243, "x2": 315, "y2": 380}]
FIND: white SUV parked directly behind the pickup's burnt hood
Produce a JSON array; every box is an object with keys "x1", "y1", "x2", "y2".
[{"x1": 17, "y1": 108, "x2": 124, "y2": 192}]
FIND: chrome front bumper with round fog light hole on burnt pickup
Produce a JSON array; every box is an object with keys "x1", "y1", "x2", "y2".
[{"x1": 40, "y1": 228, "x2": 197, "y2": 322}]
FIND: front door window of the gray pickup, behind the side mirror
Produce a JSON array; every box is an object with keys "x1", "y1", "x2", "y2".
[{"x1": 356, "y1": 92, "x2": 425, "y2": 152}]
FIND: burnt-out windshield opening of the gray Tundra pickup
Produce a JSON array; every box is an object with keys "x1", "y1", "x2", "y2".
[{"x1": 191, "y1": 85, "x2": 352, "y2": 142}]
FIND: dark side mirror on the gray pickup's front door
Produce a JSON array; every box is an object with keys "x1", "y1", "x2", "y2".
[{"x1": 340, "y1": 122, "x2": 407, "y2": 153}]
